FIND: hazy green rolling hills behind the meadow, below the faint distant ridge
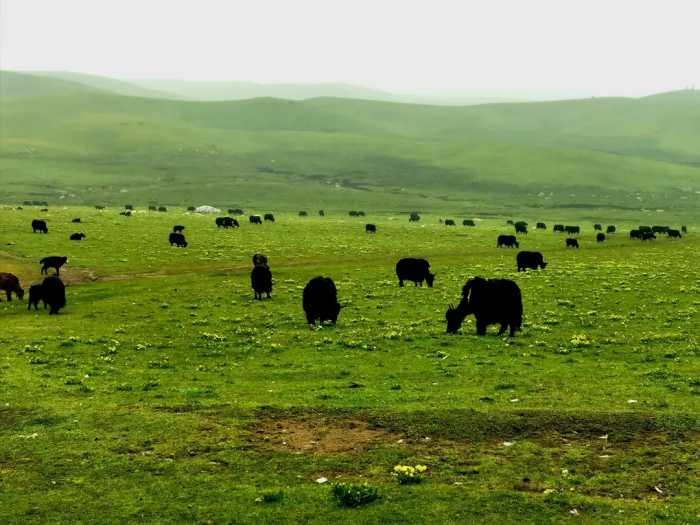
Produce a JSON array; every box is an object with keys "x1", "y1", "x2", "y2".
[{"x1": 0, "y1": 72, "x2": 700, "y2": 214}]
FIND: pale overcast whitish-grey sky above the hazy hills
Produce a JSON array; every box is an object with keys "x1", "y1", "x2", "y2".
[{"x1": 0, "y1": 0, "x2": 700, "y2": 96}]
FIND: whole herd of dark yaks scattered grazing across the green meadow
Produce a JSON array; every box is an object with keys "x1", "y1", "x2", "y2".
[{"x1": 0, "y1": 207, "x2": 687, "y2": 336}]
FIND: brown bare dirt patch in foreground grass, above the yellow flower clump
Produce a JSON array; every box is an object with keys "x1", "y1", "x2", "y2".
[{"x1": 249, "y1": 417, "x2": 400, "y2": 454}]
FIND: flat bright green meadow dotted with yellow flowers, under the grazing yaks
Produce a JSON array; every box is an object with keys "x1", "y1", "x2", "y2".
[{"x1": 0, "y1": 207, "x2": 700, "y2": 523}]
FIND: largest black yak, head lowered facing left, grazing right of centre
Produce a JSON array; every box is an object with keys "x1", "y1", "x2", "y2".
[{"x1": 445, "y1": 277, "x2": 523, "y2": 337}]
